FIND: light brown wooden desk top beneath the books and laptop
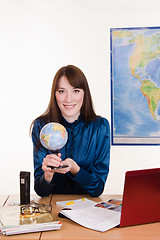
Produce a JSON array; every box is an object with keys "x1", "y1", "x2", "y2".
[{"x1": 0, "y1": 195, "x2": 160, "y2": 240}]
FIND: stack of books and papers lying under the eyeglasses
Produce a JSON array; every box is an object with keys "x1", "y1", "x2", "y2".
[{"x1": 0, "y1": 206, "x2": 61, "y2": 235}]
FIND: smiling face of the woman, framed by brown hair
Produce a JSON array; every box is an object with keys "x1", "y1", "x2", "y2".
[{"x1": 55, "y1": 76, "x2": 84, "y2": 122}]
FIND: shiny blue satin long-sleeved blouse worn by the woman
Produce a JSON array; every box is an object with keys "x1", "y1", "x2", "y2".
[{"x1": 32, "y1": 116, "x2": 110, "y2": 197}]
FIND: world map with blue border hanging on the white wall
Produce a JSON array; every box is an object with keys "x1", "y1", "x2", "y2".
[{"x1": 111, "y1": 27, "x2": 160, "y2": 144}]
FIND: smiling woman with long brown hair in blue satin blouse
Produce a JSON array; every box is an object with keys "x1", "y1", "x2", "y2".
[{"x1": 32, "y1": 65, "x2": 110, "y2": 197}]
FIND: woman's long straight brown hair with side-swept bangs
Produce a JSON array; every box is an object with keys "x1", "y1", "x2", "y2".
[{"x1": 31, "y1": 65, "x2": 96, "y2": 128}]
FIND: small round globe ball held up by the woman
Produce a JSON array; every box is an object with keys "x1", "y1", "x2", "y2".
[{"x1": 40, "y1": 122, "x2": 68, "y2": 151}]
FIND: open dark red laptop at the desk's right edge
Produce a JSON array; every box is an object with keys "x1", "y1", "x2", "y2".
[{"x1": 119, "y1": 168, "x2": 160, "y2": 227}]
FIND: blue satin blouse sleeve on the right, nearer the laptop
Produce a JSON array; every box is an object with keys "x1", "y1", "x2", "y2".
[{"x1": 66, "y1": 118, "x2": 110, "y2": 197}]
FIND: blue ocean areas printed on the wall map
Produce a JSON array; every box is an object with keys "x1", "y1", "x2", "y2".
[{"x1": 112, "y1": 44, "x2": 160, "y2": 138}]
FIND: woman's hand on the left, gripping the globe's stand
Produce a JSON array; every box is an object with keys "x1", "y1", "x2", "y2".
[{"x1": 42, "y1": 153, "x2": 63, "y2": 183}]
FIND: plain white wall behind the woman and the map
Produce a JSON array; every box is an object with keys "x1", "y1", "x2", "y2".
[{"x1": 0, "y1": 0, "x2": 160, "y2": 194}]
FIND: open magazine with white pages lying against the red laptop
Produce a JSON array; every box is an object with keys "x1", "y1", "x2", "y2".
[{"x1": 57, "y1": 198, "x2": 121, "y2": 232}]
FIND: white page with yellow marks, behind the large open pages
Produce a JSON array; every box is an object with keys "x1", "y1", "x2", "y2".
[{"x1": 56, "y1": 198, "x2": 96, "y2": 209}]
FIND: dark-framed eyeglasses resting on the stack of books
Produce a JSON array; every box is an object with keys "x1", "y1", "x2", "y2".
[{"x1": 21, "y1": 202, "x2": 52, "y2": 215}]
